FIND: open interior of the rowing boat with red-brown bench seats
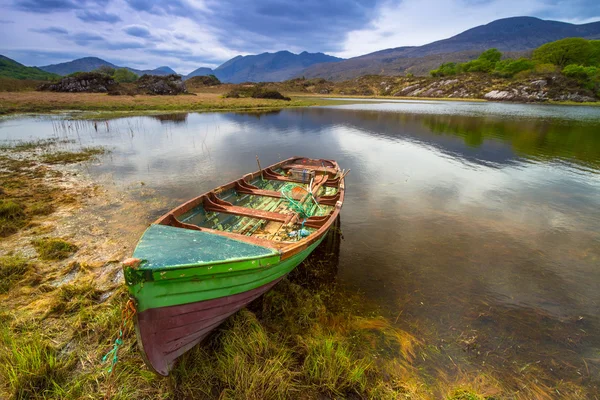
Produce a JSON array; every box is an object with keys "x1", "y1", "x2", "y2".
[{"x1": 157, "y1": 157, "x2": 349, "y2": 244}]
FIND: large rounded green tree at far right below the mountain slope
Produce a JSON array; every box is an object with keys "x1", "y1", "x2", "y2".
[{"x1": 533, "y1": 38, "x2": 594, "y2": 68}]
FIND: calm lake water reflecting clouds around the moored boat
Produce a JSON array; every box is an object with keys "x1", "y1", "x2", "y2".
[{"x1": 0, "y1": 101, "x2": 600, "y2": 394}]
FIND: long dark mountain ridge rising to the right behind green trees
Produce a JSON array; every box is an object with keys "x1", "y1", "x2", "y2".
[{"x1": 296, "y1": 17, "x2": 600, "y2": 80}]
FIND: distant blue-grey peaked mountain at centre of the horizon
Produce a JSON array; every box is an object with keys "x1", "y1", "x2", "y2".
[{"x1": 213, "y1": 51, "x2": 343, "y2": 83}]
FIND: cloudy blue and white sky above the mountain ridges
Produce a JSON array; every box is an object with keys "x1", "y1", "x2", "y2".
[{"x1": 0, "y1": 0, "x2": 600, "y2": 74}]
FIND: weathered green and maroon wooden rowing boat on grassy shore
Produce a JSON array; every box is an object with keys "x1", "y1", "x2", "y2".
[{"x1": 123, "y1": 157, "x2": 345, "y2": 375}]
